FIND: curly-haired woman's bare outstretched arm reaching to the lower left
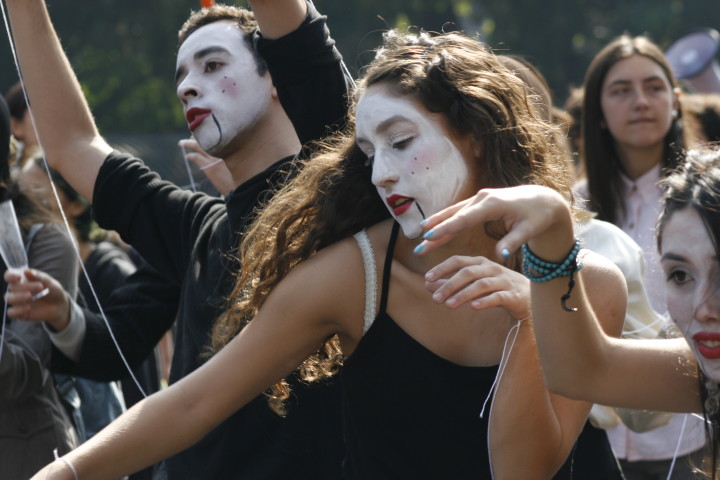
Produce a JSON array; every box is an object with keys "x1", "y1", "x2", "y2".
[{"x1": 29, "y1": 239, "x2": 364, "y2": 480}]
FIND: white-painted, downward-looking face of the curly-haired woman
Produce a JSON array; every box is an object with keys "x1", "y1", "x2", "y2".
[{"x1": 356, "y1": 84, "x2": 473, "y2": 238}]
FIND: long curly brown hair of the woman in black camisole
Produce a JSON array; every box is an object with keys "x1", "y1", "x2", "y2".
[{"x1": 212, "y1": 30, "x2": 570, "y2": 413}]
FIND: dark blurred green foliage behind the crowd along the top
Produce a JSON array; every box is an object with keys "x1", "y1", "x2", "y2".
[{"x1": 0, "y1": 0, "x2": 720, "y2": 133}]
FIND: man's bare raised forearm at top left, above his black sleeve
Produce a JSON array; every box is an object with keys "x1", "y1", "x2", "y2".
[{"x1": 7, "y1": 0, "x2": 111, "y2": 198}]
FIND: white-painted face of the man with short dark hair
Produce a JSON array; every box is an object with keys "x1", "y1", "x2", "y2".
[{"x1": 175, "y1": 21, "x2": 272, "y2": 157}]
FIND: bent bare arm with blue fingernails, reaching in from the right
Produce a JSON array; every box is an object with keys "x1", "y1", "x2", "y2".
[{"x1": 423, "y1": 186, "x2": 700, "y2": 412}]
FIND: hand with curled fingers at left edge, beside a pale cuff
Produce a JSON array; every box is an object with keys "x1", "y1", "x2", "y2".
[{"x1": 4, "y1": 268, "x2": 70, "y2": 331}]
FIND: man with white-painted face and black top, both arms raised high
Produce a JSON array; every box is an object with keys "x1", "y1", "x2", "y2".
[{"x1": 2, "y1": 0, "x2": 350, "y2": 479}]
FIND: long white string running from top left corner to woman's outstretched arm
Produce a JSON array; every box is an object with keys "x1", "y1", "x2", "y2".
[{"x1": 0, "y1": 0, "x2": 147, "y2": 397}]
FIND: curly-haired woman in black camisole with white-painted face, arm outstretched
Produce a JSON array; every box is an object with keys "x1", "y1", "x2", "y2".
[{"x1": 36, "y1": 31, "x2": 625, "y2": 480}]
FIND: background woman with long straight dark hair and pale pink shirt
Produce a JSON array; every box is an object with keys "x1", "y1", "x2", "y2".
[{"x1": 577, "y1": 35, "x2": 705, "y2": 480}]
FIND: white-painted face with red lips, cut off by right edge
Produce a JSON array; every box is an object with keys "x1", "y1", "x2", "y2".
[{"x1": 661, "y1": 208, "x2": 720, "y2": 382}]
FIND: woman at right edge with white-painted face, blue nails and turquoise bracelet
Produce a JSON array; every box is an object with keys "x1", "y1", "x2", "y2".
[{"x1": 416, "y1": 149, "x2": 720, "y2": 478}]
